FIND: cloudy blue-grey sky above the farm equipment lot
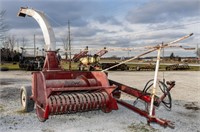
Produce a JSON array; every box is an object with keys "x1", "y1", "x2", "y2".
[{"x1": 0, "y1": 0, "x2": 200, "y2": 56}]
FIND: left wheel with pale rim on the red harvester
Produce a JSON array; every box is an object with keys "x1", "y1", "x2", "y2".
[{"x1": 20, "y1": 86, "x2": 34, "y2": 112}]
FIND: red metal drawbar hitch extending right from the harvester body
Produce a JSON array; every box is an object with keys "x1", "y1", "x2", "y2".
[{"x1": 109, "y1": 80, "x2": 175, "y2": 128}]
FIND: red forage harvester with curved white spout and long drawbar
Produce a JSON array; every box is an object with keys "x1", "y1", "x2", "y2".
[{"x1": 18, "y1": 8, "x2": 192, "y2": 128}]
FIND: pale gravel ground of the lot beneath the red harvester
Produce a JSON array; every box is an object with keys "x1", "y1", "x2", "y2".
[{"x1": 0, "y1": 71, "x2": 200, "y2": 132}]
